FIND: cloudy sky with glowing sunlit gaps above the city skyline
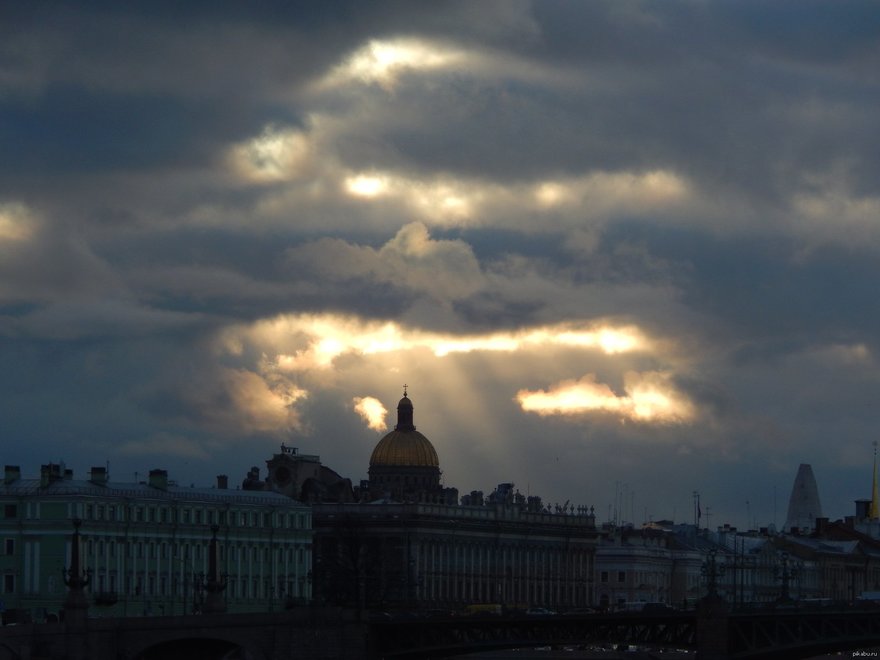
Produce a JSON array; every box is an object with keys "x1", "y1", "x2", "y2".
[{"x1": 0, "y1": 0, "x2": 880, "y2": 528}]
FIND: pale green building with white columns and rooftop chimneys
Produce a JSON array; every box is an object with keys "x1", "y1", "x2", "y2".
[{"x1": 0, "y1": 464, "x2": 312, "y2": 620}]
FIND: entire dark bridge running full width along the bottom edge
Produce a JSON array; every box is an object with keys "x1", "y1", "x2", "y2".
[{"x1": 0, "y1": 602, "x2": 880, "y2": 660}]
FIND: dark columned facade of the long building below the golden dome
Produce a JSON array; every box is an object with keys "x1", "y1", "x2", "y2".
[{"x1": 314, "y1": 503, "x2": 598, "y2": 610}]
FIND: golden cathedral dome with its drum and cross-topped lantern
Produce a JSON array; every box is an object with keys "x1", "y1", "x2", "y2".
[{"x1": 368, "y1": 385, "x2": 457, "y2": 502}]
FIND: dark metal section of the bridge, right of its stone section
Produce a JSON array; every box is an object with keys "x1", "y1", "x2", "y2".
[{"x1": 371, "y1": 606, "x2": 880, "y2": 660}]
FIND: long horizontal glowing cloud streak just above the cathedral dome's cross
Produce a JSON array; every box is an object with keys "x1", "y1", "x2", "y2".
[{"x1": 224, "y1": 314, "x2": 653, "y2": 372}]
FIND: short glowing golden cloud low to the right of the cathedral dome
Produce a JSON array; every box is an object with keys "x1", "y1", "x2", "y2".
[{"x1": 516, "y1": 371, "x2": 696, "y2": 424}]
